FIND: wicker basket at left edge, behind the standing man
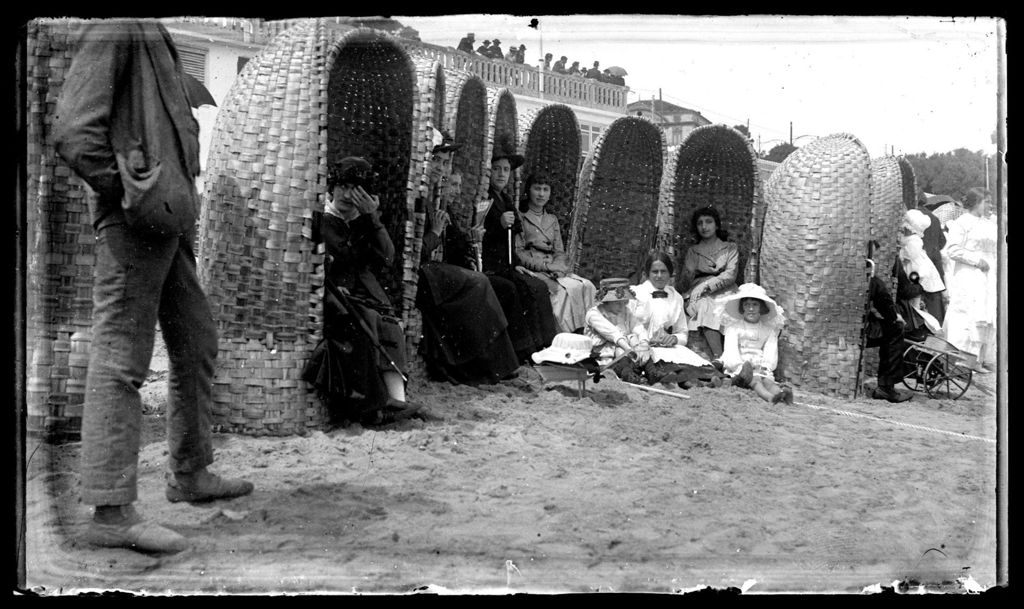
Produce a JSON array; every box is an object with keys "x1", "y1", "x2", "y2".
[{"x1": 24, "y1": 19, "x2": 95, "y2": 441}]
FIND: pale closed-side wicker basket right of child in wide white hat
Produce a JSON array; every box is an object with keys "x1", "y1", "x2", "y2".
[{"x1": 761, "y1": 134, "x2": 871, "y2": 396}]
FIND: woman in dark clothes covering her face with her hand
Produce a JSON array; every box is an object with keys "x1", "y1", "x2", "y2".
[{"x1": 303, "y1": 157, "x2": 428, "y2": 424}]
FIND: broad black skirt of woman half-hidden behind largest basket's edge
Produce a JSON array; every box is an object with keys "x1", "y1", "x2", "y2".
[{"x1": 416, "y1": 262, "x2": 518, "y2": 383}]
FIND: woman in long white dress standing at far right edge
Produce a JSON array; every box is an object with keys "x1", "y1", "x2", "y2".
[{"x1": 943, "y1": 188, "x2": 998, "y2": 367}]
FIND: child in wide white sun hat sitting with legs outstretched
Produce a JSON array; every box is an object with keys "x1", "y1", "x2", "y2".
[{"x1": 722, "y1": 284, "x2": 793, "y2": 404}]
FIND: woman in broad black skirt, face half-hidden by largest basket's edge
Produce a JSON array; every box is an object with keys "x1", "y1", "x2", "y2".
[{"x1": 416, "y1": 133, "x2": 519, "y2": 384}]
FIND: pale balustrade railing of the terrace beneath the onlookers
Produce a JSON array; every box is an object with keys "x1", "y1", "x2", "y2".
[{"x1": 176, "y1": 17, "x2": 629, "y2": 115}]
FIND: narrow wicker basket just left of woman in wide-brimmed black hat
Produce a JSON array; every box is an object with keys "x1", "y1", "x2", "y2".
[{"x1": 446, "y1": 70, "x2": 490, "y2": 226}]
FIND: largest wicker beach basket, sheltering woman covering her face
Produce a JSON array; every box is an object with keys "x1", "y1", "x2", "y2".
[{"x1": 199, "y1": 19, "x2": 425, "y2": 435}]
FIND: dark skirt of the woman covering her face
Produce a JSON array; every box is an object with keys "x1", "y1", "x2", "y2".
[{"x1": 302, "y1": 295, "x2": 407, "y2": 421}]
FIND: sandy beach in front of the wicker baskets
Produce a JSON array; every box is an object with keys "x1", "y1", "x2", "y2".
[{"x1": 26, "y1": 337, "x2": 995, "y2": 595}]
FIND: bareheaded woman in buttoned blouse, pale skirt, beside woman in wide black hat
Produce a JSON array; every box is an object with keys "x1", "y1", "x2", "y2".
[{"x1": 515, "y1": 171, "x2": 597, "y2": 332}]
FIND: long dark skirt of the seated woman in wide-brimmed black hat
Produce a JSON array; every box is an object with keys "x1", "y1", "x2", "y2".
[{"x1": 487, "y1": 272, "x2": 558, "y2": 361}]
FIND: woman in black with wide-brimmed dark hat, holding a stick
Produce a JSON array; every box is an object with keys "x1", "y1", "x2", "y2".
[{"x1": 481, "y1": 137, "x2": 558, "y2": 362}]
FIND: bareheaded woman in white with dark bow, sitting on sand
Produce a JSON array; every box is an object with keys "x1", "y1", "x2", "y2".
[{"x1": 632, "y1": 251, "x2": 719, "y2": 386}]
